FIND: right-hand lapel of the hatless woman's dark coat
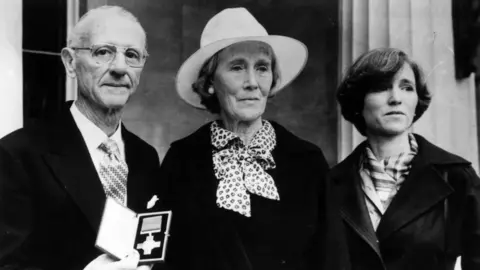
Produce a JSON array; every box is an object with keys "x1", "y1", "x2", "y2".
[{"x1": 377, "y1": 153, "x2": 453, "y2": 241}]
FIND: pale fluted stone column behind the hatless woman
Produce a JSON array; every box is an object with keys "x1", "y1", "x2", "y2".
[{"x1": 338, "y1": 0, "x2": 478, "y2": 172}]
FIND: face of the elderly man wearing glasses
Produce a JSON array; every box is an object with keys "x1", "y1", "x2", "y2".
[{"x1": 75, "y1": 16, "x2": 145, "y2": 109}]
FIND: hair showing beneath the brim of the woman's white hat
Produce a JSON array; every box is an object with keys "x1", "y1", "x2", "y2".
[{"x1": 192, "y1": 41, "x2": 280, "y2": 114}]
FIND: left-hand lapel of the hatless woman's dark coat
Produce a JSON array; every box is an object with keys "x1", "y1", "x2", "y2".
[{"x1": 332, "y1": 145, "x2": 381, "y2": 259}]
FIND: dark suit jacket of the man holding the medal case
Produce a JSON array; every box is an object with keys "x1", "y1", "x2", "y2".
[{"x1": 0, "y1": 102, "x2": 159, "y2": 270}]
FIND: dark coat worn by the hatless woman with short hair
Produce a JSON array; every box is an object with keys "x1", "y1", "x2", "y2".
[{"x1": 327, "y1": 135, "x2": 480, "y2": 270}]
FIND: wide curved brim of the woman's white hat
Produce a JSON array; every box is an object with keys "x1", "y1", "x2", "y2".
[{"x1": 176, "y1": 35, "x2": 308, "y2": 109}]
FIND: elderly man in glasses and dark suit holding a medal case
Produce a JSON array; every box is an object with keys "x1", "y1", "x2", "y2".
[{"x1": 0, "y1": 6, "x2": 159, "y2": 270}]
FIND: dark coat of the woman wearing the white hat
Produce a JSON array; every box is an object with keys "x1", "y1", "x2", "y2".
[{"x1": 160, "y1": 122, "x2": 328, "y2": 270}]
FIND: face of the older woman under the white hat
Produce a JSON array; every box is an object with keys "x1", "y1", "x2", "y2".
[{"x1": 213, "y1": 41, "x2": 273, "y2": 122}]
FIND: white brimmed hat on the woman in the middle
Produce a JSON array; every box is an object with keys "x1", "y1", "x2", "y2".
[{"x1": 176, "y1": 8, "x2": 308, "y2": 109}]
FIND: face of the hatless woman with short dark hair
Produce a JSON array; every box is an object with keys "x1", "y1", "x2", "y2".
[{"x1": 362, "y1": 63, "x2": 418, "y2": 136}]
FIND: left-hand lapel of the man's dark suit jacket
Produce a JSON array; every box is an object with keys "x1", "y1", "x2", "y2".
[{"x1": 44, "y1": 108, "x2": 105, "y2": 231}]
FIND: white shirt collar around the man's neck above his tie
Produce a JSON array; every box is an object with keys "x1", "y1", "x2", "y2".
[{"x1": 70, "y1": 102, "x2": 123, "y2": 153}]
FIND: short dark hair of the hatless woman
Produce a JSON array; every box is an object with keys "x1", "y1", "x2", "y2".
[{"x1": 337, "y1": 48, "x2": 432, "y2": 136}]
